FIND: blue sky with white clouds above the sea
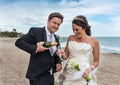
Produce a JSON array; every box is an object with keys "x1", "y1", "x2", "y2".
[{"x1": 0, "y1": 0, "x2": 120, "y2": 37}]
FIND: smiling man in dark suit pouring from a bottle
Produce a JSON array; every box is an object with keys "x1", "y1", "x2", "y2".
[{"x1": 15, "y1": 12, "x2": 63, "y2": 85}]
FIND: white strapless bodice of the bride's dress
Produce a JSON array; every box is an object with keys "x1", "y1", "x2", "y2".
[{"x1": 68, "y1": 41, "x2": 93, "y2": 63}]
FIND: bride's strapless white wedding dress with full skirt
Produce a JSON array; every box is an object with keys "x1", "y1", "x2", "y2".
[{"x1": 55, "y1": 41, "x2": 98, "y2": 85}]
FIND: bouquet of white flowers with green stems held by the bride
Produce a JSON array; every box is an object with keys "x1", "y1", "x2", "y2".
[{"x1": 68, "y1": 59, "x2": 91, "y2": 82}]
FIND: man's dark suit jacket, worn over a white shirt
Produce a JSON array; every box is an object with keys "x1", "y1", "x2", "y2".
[{"x1": 15, "y1": 27, "x2": 61, "y2": 79}]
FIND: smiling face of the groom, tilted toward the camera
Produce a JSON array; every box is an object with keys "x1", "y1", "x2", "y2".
[{"x1": 48, "y1": 17, "x2": 61, "y2": 33}]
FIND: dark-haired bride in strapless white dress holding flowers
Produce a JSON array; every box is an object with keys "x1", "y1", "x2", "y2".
[{"x1": 55, "y1": 15, "x2": 100, "y2": 85}]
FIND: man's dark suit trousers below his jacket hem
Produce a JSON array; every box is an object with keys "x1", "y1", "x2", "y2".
[{"x1": 30, "y1": 72, "x2": 54, "y2": 85}]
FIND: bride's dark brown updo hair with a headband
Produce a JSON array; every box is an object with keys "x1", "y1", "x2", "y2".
[{"x1": 72, "y1": 15, "x2": 91, "y2": 36}]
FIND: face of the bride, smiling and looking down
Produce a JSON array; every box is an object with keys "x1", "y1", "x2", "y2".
[{"x1": 72, "y1": 24, "x2": 83, "y2": 38}]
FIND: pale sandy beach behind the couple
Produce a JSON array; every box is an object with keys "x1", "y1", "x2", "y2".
[{"x1": 0, "y1": 37, "x2": 120, "y2": 85}]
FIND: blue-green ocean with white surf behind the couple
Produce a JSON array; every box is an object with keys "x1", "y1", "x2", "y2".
[{"x1": 60, "y1": 37, "x2": 120, "y2": 54}]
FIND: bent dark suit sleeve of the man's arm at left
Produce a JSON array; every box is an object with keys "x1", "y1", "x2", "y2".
[{"x1": 15, "y1": 28, "x2": 37, "y2": 54}]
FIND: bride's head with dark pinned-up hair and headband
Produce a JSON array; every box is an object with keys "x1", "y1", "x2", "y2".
[{"x1": 72, "y1": 15, "x2": 91, "y2": 37}]
